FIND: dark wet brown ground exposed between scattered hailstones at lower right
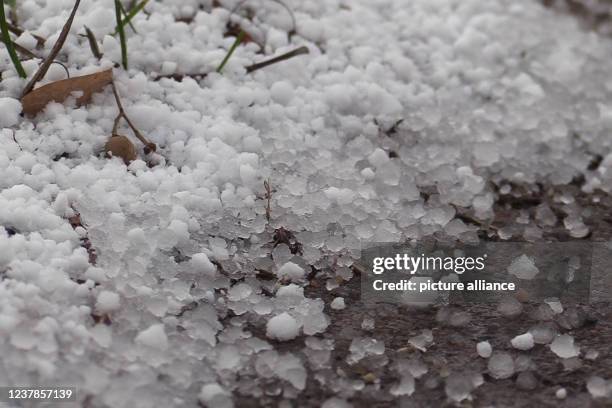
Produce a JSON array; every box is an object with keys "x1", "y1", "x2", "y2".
[{"x1": 236, "y1": 180, "x2": 612, "y2": 407}]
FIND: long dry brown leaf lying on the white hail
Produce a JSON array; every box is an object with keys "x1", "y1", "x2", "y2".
[{"x1": 21, "y1": 68, "x2": 113, "y2": 115}]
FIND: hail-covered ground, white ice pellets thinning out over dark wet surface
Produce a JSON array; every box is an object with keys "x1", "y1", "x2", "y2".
[{"x1": 0, "y1": 0, "x2": 612, "y2": 408}]
